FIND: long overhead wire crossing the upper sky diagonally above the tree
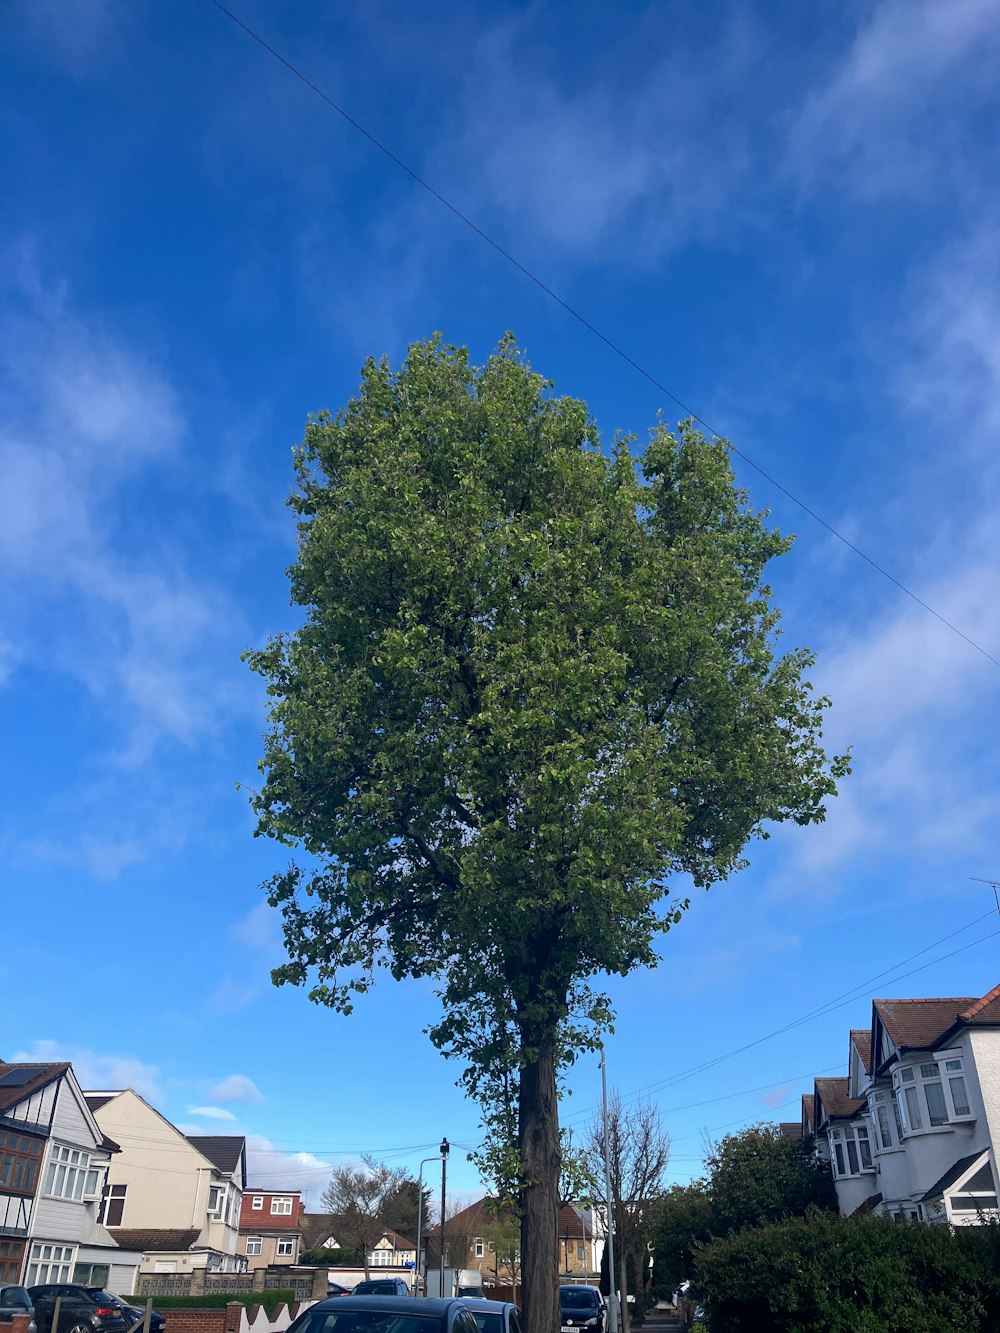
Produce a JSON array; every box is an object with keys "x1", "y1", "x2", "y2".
[{"x1": 211, "y1": 0, "x2": 1000, "y2": 667}]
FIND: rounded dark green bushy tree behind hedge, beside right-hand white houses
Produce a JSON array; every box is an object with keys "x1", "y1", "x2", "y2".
[{"x1": 705, "y1": 1125, "x2": 837, "y2": 1234}]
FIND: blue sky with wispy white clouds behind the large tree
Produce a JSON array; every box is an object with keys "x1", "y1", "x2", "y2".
[{"x1": 0, "y1": 0, "x2": 1000, "y2": 1202}]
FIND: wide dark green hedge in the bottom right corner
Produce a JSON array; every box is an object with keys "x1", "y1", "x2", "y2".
[{"x1": 695, "y1": 1210, "x2": 1000, "y2": 1333}]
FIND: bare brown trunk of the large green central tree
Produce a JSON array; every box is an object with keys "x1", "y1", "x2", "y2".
[{"x1": 517, "y1": 1033, "x2": 561, "y2": 1333}]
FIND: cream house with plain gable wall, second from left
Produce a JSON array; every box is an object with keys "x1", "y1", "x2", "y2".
[{"x1": 87, "y1": 1088, "x2": 247, "y2": 1273}]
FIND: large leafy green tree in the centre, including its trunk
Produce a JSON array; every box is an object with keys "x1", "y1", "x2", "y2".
[{"x1": 248, "y1": 337, "x2": 845, "y2": 1333}]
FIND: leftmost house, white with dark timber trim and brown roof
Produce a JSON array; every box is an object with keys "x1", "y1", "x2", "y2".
[{"x1": 0, "y1": 1061, "x2": 139, "y2": 1292}]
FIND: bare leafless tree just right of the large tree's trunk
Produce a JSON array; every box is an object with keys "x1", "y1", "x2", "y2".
[{"x1": 587, "y1": 1092, "x2": 671, "y2": 1333}]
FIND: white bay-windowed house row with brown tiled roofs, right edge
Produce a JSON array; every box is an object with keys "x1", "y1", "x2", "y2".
[{"x1": 803, "y1": 986, "x2": 1000, "y2": 1226}]
